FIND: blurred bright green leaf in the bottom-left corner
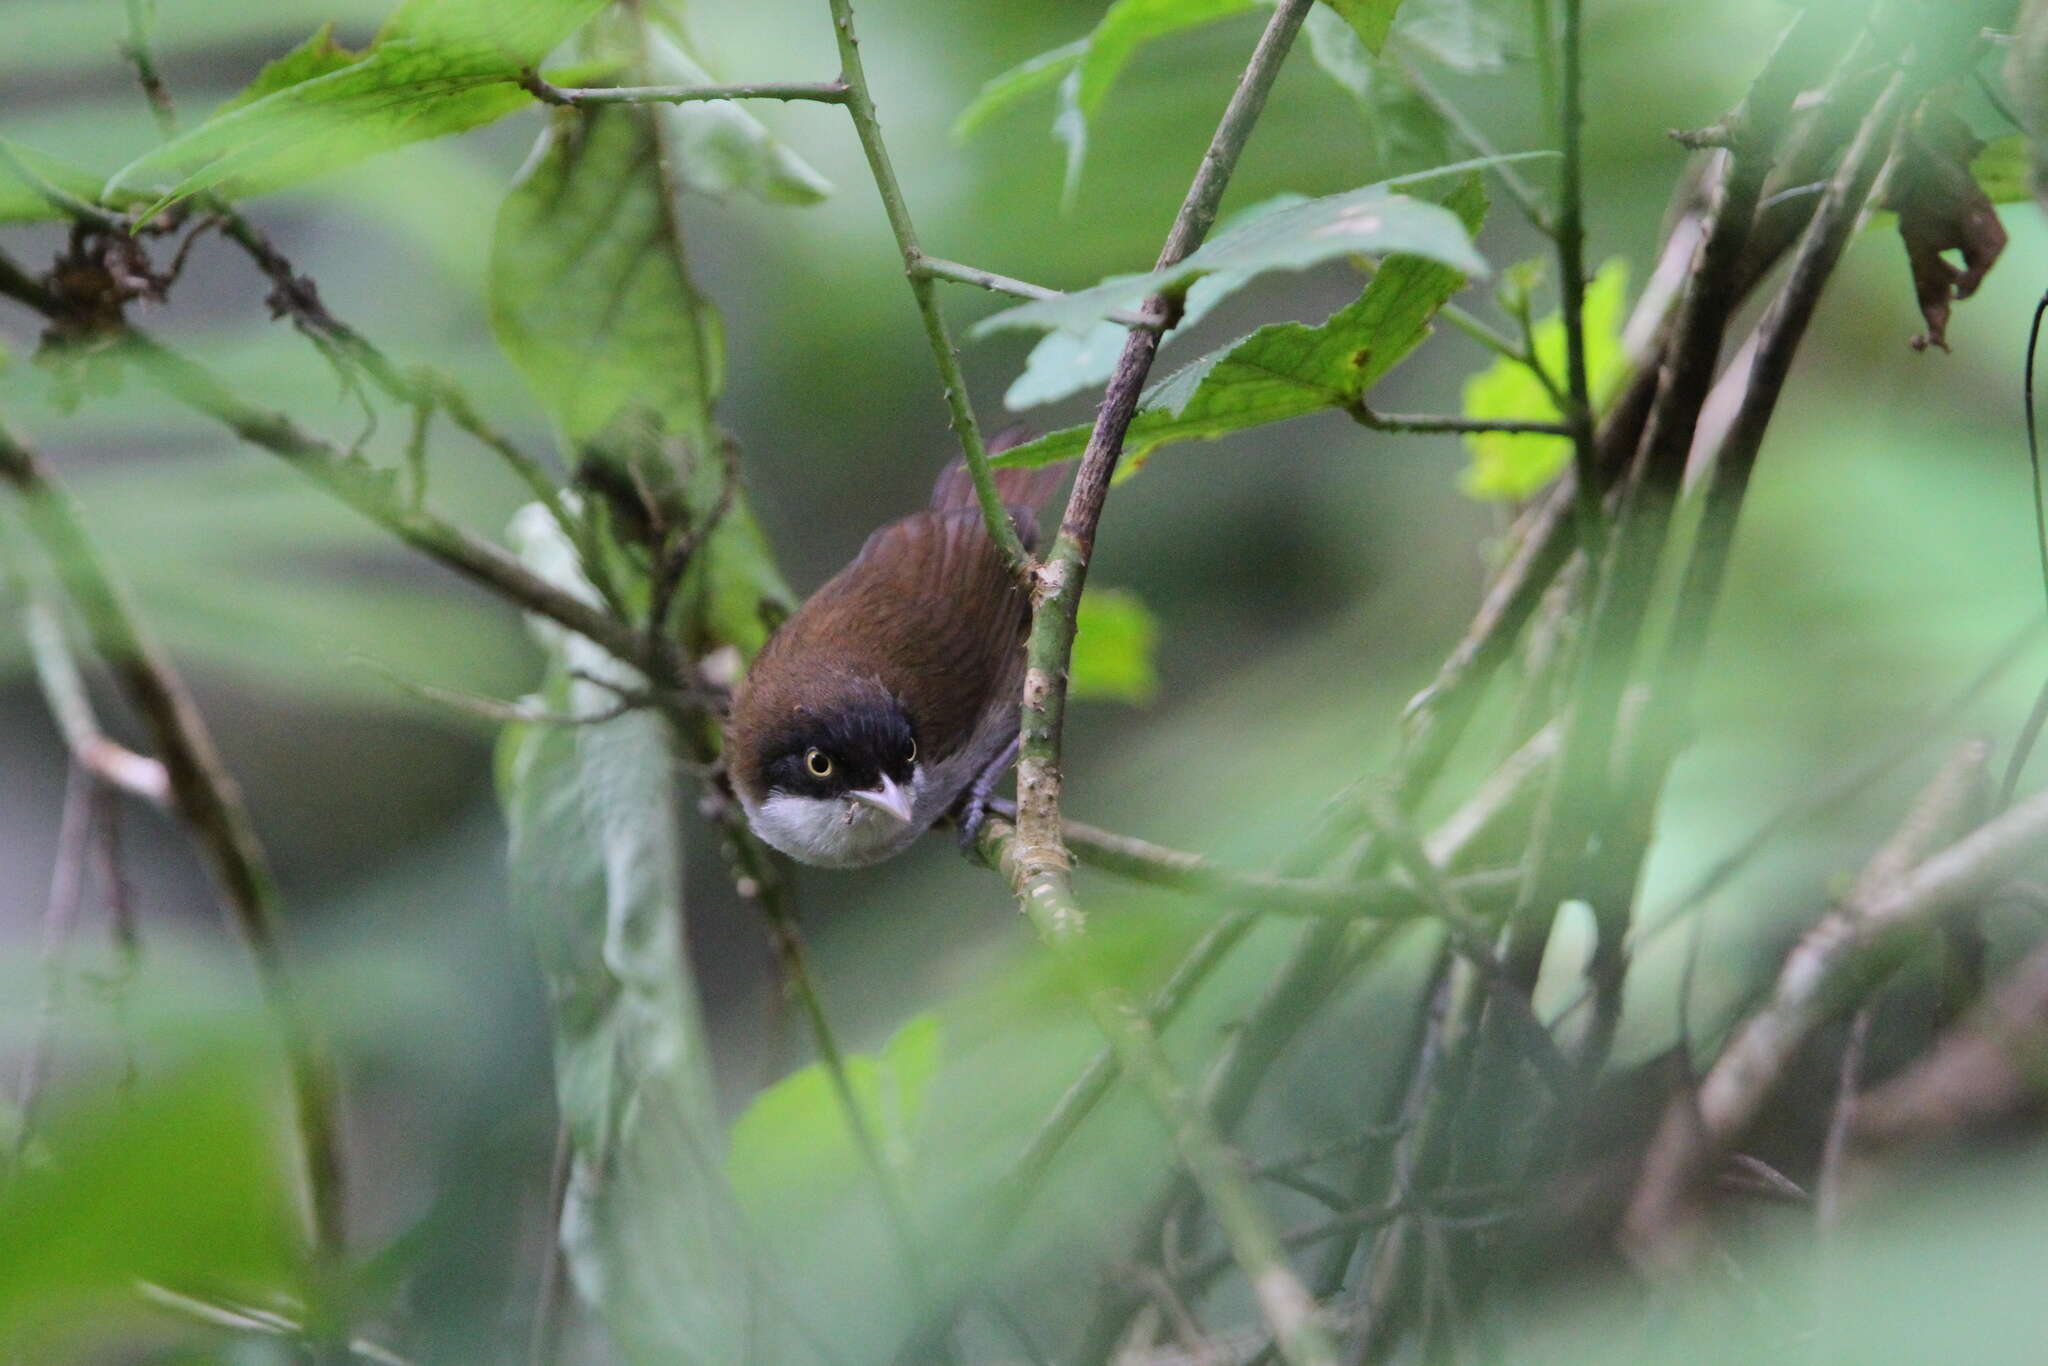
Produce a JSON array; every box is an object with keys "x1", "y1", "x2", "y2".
[{"x1": 0, "y1": 1049, "x2": 301, "y2": 1360}]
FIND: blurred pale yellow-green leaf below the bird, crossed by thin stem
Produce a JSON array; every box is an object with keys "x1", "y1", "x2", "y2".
[{"x1": 725, "y1": 1014, "x2": 940, "y2": 1219}]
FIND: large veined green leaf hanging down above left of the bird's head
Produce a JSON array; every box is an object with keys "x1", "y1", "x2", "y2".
[{"x1": 489, "y1": 109, "x2": 788, "y2": 653}]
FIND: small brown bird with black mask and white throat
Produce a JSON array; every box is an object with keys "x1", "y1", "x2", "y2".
[{"x1": 725, "y1": 454, "x2": 1063, "y2": 868}]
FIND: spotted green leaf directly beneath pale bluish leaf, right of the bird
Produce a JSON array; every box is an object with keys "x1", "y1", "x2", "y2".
[{"x1": 995, "y1": 176, "x2": 1487, "y2": 473}]
